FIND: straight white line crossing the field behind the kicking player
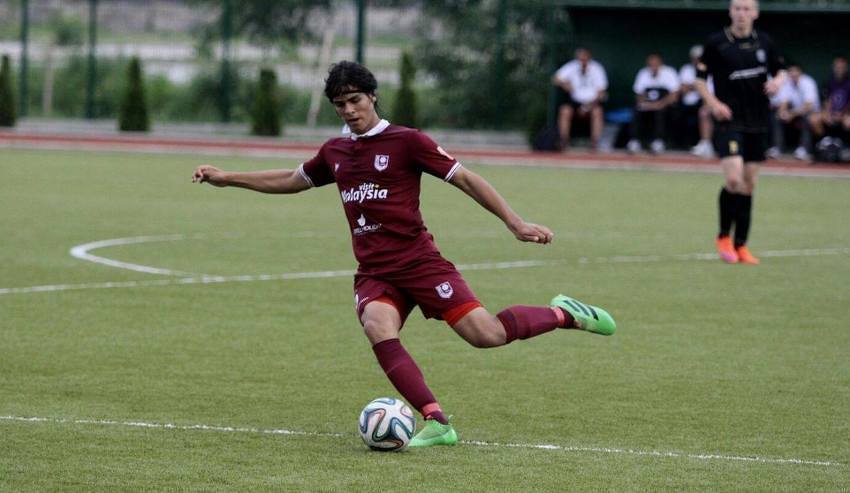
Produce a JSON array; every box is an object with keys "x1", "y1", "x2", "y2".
[{"x1": 0, "y1": 247, "x2": 850, "y2": 295}]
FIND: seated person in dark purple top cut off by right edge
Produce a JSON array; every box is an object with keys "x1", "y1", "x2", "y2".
[{"x1": 810, "y1": 56, "x2": 850, "y2": 144}]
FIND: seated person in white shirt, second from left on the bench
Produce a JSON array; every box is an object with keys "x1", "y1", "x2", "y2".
[{"x1": 627, "y1": 53, "x2": 680, "y2": 154}]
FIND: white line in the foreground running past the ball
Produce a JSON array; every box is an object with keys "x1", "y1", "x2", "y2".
[{"x1": 0, "y1": 416, "x2": 844, "y2": 467}]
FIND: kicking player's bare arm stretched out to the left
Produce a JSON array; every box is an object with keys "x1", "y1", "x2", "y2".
[{"x1": 192, "y1": 164, "x2": 310, "y2": 193}]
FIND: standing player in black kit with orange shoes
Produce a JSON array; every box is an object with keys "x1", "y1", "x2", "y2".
[{"x1": 696, "y1": 0, "x2": 785, "y2": 264}]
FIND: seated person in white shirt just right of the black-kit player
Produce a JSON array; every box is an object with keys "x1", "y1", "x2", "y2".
[{"x1": 767, "y1": 63, "x2": 820, "y2": 161}]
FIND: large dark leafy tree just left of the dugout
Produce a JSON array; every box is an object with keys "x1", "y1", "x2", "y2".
[{"x1": 417, "y1": 0, "x2": 559, "y2": 128}]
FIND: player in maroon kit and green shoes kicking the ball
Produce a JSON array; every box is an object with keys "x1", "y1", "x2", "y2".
[{"x1": 192, "y1": 61, "x2": 616, "y2": 447}]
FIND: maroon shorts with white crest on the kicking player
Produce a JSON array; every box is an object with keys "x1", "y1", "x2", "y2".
[{"x1": 354, "y1": 257, "x2": 481, "y2": 324}]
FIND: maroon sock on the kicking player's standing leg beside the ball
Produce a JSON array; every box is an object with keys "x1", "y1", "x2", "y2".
[{"x1": 372, "y1": 339, "x2": 448, "y2": 424}]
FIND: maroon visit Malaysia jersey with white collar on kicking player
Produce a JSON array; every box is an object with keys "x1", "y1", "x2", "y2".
[{"x1": 298, "y1": 120, "x2": 460, "y2": 274}]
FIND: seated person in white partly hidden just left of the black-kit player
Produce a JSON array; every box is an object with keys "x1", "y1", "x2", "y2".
[{"x1": 678, "y1": 45, "x2": 714, "y2": 158}]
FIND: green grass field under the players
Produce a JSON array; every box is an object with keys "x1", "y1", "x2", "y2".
[{"x1": 0, "y1": 149, "x2": 850, "y2": 491}]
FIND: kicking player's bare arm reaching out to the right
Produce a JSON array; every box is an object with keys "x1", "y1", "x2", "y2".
[{"x1": 449, "y1": 167, "x2": 554, "y2": 244}]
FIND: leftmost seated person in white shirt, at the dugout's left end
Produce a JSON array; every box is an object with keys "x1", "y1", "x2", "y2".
[{"x1": 552, "y1": 48, "x2": 608, "y2": 150}]
